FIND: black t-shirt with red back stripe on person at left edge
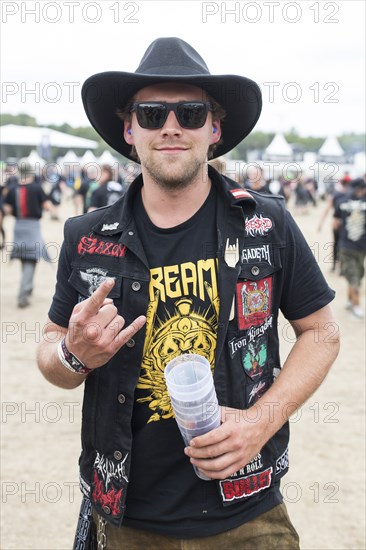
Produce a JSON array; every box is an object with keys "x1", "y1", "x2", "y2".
[{"x1": 4, "y1": 182, "x2": 47, "y2": 219}]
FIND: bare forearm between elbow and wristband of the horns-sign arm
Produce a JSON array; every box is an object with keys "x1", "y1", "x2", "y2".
[{"x1": 37, "y1": 331, "x2": 86, "y2": 389}]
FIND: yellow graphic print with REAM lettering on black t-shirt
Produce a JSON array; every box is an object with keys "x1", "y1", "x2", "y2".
[{"x1": 137, "y1": 259, "x2": 219, "y2": 422}]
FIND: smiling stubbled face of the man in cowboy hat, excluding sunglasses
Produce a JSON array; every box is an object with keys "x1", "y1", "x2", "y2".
[{"x1": 124, "y1": 83, "x2": 221, "y2": 189}]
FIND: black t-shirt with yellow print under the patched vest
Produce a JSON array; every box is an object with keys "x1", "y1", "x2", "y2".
[{"x1": 124, "y1": 188, "x2": 279, "y2": 538}]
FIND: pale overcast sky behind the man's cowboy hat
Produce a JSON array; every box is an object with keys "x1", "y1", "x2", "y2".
[{"x1": 0, "y1": 0, "x2": 365, "y2": 136}]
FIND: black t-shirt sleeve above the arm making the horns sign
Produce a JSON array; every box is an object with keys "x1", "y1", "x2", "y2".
[{"x1": 48, "y1": 220, "x2": 78, "y2": 328}]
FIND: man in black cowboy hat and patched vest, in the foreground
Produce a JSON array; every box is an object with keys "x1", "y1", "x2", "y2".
[{"x1": 38, "y1": 38, "x2": 338, "y2": 550}]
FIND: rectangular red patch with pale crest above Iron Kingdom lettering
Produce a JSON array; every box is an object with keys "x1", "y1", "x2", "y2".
[{"x1": 236, "y1": 277, "x2": 272, "y2": 330}]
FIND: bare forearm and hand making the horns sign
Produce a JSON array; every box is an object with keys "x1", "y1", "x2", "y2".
[{"x1": 37, "y1": 279, "x2": 146, "y2": 389}]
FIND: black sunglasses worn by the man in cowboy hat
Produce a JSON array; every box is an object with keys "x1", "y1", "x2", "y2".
[{"x1": 131, "y1": 101, "x2": 212, "y2": 130}]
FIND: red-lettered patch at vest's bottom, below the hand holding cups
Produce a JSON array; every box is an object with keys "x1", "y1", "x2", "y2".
[{"x1": 219, "y1": 467, "x2": 272, "y2": 504}]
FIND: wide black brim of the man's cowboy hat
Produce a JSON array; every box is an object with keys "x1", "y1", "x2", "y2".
[{"x1": 81, "y1": 71, "x2": 262, "y2": 162}]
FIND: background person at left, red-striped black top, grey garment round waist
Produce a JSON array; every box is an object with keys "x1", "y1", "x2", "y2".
[{"x1": 3, "y1": 163, "x2": 53, "y2": 308}]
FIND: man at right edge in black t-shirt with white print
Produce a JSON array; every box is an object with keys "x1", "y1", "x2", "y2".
[{"x1": 334, "y1": 178, "x2": 366, "y2": 319}]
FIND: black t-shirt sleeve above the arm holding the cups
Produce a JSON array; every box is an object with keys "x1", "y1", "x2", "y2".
[{"x1": 280, "y1": 212, "x2": 335, "y2": 320}]
